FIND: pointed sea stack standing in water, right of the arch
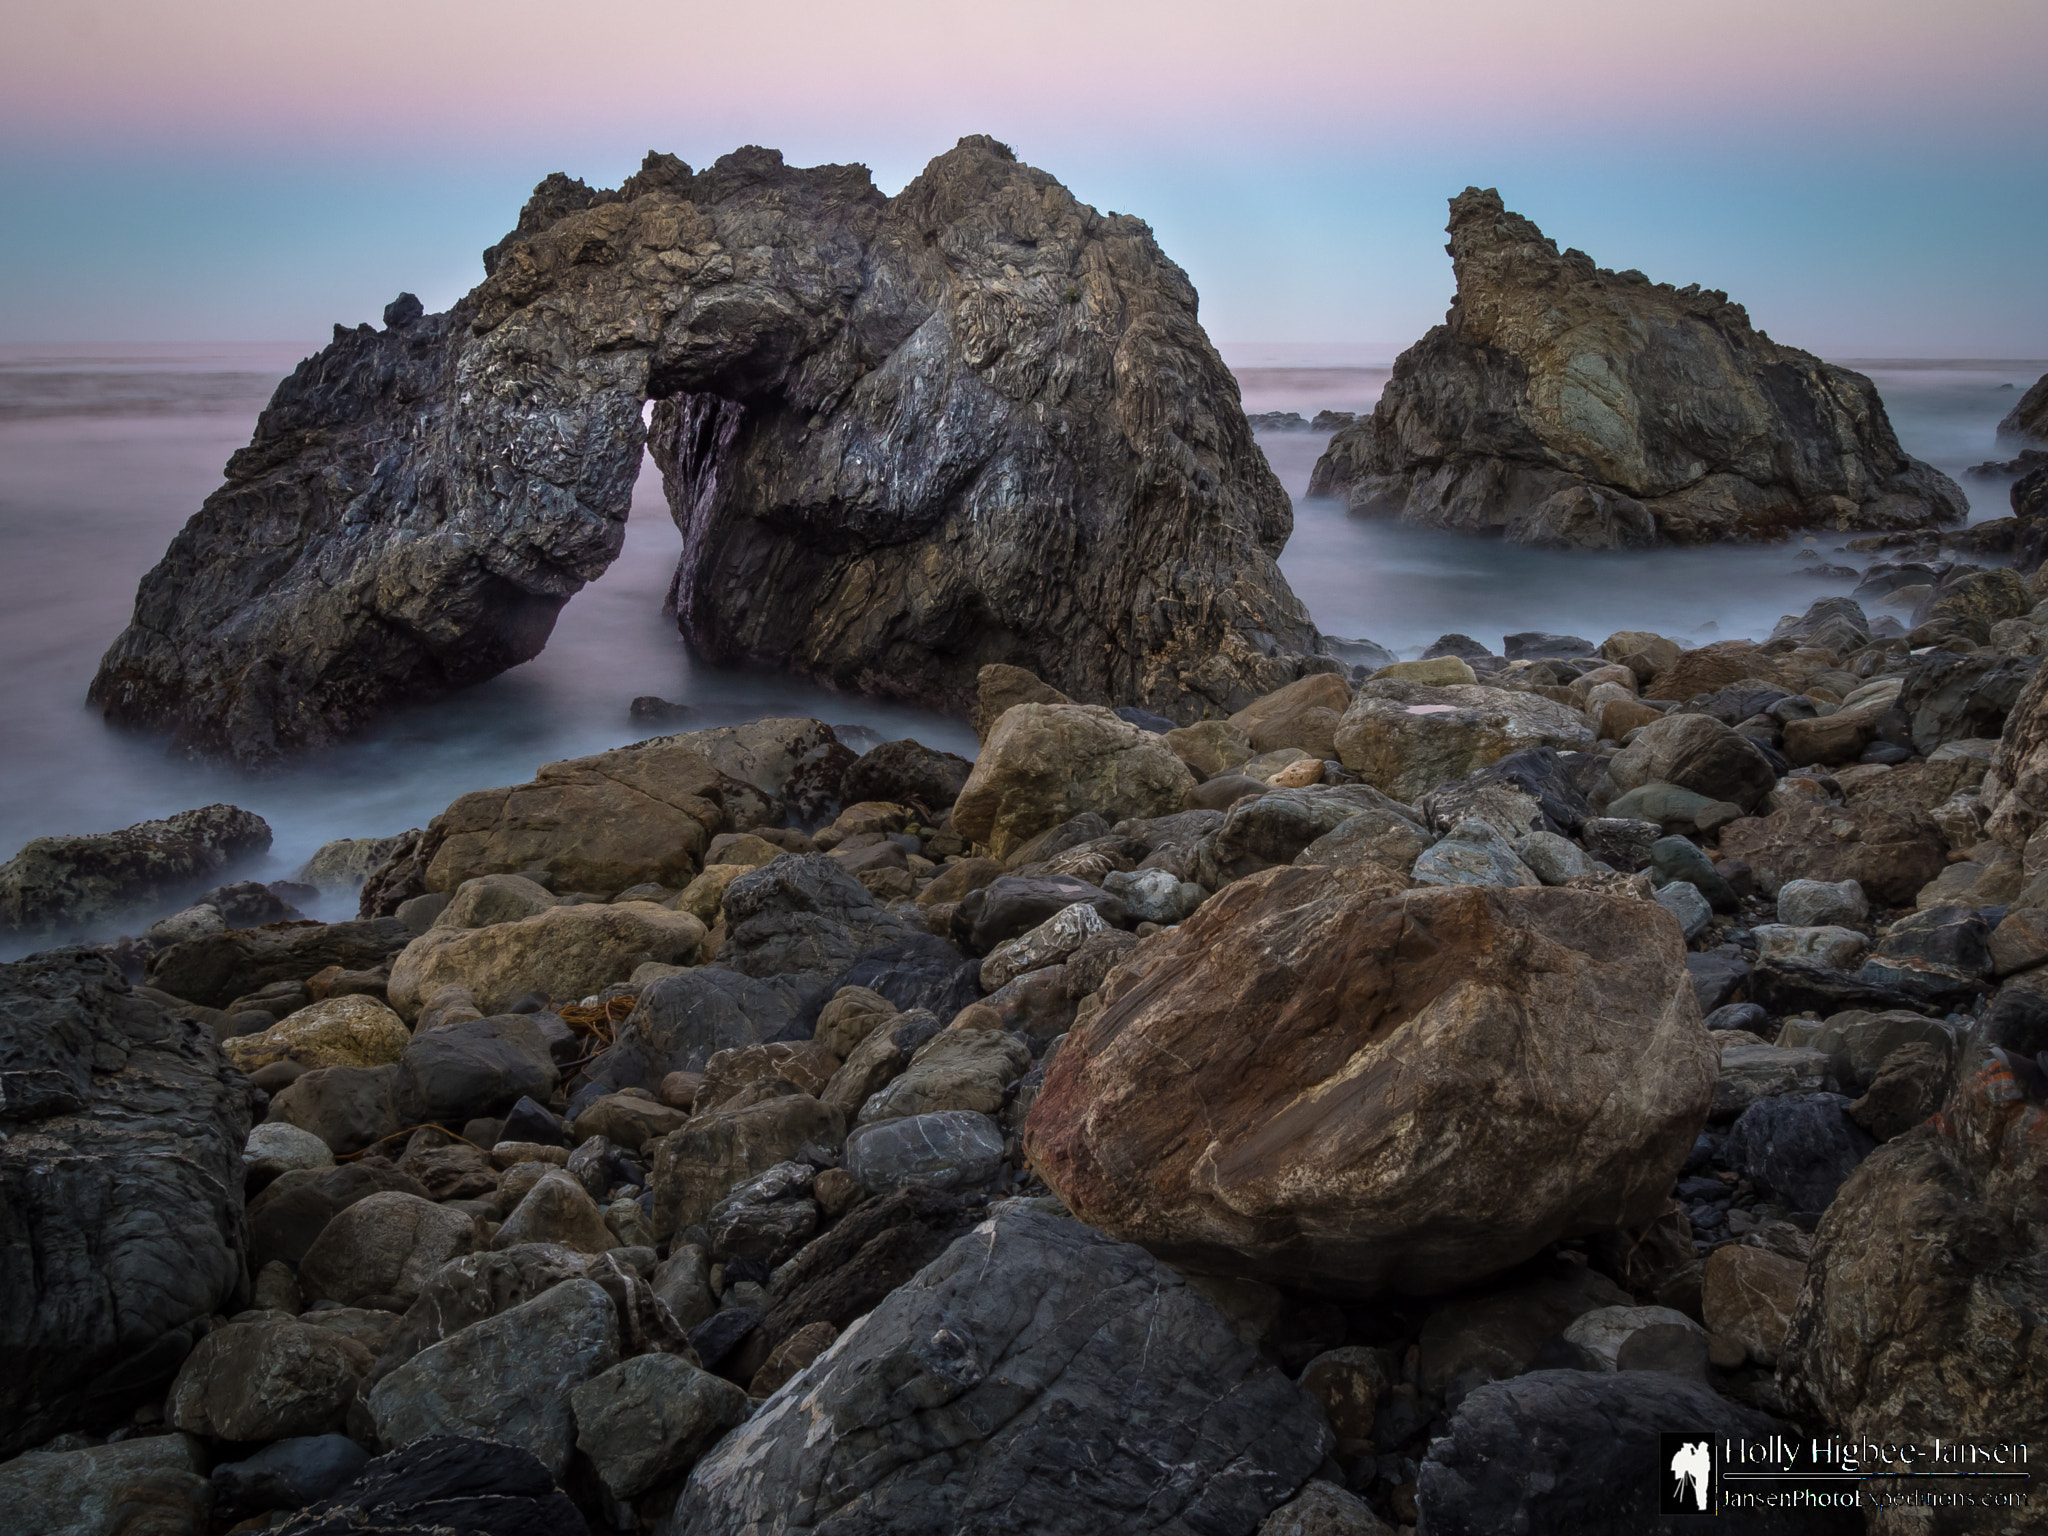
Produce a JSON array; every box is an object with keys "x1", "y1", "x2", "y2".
[{"x1": 1309, "y1": 186, "x2": 1966, "y2": 549}]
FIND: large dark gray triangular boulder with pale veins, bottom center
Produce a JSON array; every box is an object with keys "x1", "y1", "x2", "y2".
[{"x1": 662, "y1": 1210, "x2": 1331, "y2": 1536}]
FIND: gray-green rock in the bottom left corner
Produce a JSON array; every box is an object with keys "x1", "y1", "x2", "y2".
[{"x1": 0, "y1": 1434, "x2": 213, "y2": 1536}]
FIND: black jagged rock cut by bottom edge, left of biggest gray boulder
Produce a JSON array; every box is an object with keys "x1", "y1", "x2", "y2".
[{"x1": 274, "y1": 1434, "x2": 584, "y2": 1536}]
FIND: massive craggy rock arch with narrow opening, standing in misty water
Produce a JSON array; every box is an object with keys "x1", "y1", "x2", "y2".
[{"x1": 90, "y1": 137, "x2": 1315, "y2": 764}]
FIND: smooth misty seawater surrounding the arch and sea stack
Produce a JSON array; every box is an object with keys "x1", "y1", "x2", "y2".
[{"x1": 0, "y1": 346, "x2": 2048, "y2": 954}]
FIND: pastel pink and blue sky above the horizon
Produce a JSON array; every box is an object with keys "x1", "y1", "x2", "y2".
[{"x1": 0, "y1": 0, "x2": 2048, "y2": 358}]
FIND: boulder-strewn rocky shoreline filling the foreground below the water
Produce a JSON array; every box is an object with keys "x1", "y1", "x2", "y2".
[{"x1": 0, "y1": 573, "x2": 2048, "y2": 1536}]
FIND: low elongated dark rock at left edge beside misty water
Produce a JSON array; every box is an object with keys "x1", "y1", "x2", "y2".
[{"x1": 0, "y1": 805, "x2": 270, "y2": 937}]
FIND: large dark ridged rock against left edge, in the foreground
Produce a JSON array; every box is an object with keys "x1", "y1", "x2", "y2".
[{"x1": 0, "y1": 950, "x2": 250, "y2": 1456}]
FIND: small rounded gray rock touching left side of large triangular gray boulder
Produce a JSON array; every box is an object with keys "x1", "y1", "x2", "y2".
[{"x1": 569, "y1": 1354, "x2": 748, "y2": 1499}]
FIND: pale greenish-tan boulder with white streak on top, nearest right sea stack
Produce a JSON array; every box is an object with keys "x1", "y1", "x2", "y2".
[{"x1": 1335, "y1": 678, "x2": 1593, "y2": 801}]
